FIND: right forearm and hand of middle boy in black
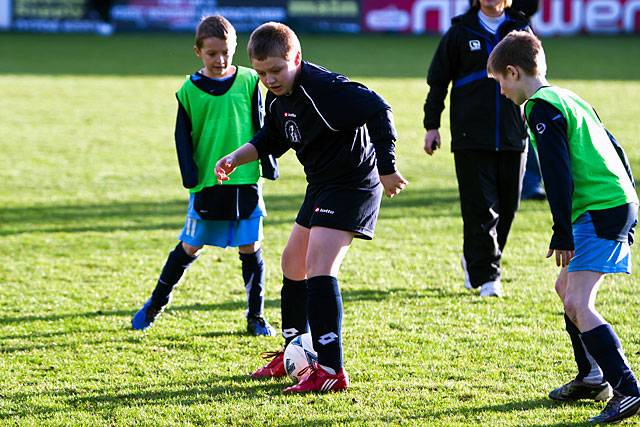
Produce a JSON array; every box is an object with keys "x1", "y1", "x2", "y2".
[{"x1": 367, "y1": 109, "x2": 409, "y2": 197}]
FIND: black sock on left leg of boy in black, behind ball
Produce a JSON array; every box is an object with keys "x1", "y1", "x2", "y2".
[{"x1": 280, "y1": 276, "x2": 309, "y2": 346}]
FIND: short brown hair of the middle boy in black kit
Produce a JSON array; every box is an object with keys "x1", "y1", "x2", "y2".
[{"x1": 247, "y1": 22, "x2": 301, "y2": 61}]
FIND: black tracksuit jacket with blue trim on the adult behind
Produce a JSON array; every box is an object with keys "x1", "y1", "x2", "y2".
[{"x1": 424, "y1": 8, "x2": 531, "y2": 151}]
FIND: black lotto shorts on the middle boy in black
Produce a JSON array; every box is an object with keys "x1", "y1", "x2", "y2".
[{"x1": 296, "y1": 184, "x2": 382, "y2": 240}]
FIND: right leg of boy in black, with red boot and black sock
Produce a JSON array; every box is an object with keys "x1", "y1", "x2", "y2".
[{"x1": 285, "y1": 227, "x2": 353, "y2": 393}]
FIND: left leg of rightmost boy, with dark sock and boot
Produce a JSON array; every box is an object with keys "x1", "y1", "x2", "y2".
[{"x1": 549, "y1": 267, "x2": 611, "y2": 401}]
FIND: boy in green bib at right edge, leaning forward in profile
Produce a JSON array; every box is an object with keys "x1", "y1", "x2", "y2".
[{"x1": 487, "y1": 32, "x2": 640, "y2": 424}]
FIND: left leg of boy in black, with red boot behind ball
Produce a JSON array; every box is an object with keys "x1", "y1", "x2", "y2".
[{"x1": 251, "y1": 224, "x2": 309, "y2": 378}]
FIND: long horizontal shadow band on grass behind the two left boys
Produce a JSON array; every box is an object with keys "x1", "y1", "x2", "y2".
[{"x1": 0, "y1": 189, "x2": 458, "y2": 236}]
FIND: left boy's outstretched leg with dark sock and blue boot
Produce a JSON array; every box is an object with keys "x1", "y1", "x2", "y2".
[{"x1": 131, "y1": 242, "x2": 202, "y2": 330}]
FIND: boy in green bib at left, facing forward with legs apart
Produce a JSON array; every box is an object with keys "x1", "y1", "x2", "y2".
[{"x1": 131, "y1": 16, "x2": 277, "y2": 336}]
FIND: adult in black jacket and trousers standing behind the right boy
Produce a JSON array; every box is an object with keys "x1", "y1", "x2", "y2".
[{"x1": 424, "y1": 0, "x2": 530, "y2": 296}]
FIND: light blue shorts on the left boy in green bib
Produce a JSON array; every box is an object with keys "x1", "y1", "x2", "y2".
[{"x1": 178, "y1": 194, "x2": 266, "y2": 248}]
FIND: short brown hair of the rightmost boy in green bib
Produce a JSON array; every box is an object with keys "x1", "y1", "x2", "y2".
[{"x1": 487, "y1": 31, "x2": 547, "y2": 76}]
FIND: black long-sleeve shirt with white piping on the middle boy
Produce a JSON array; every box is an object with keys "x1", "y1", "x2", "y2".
[{"x1": 251, "y1": 61, "x2": 397, "y2": 187}]
